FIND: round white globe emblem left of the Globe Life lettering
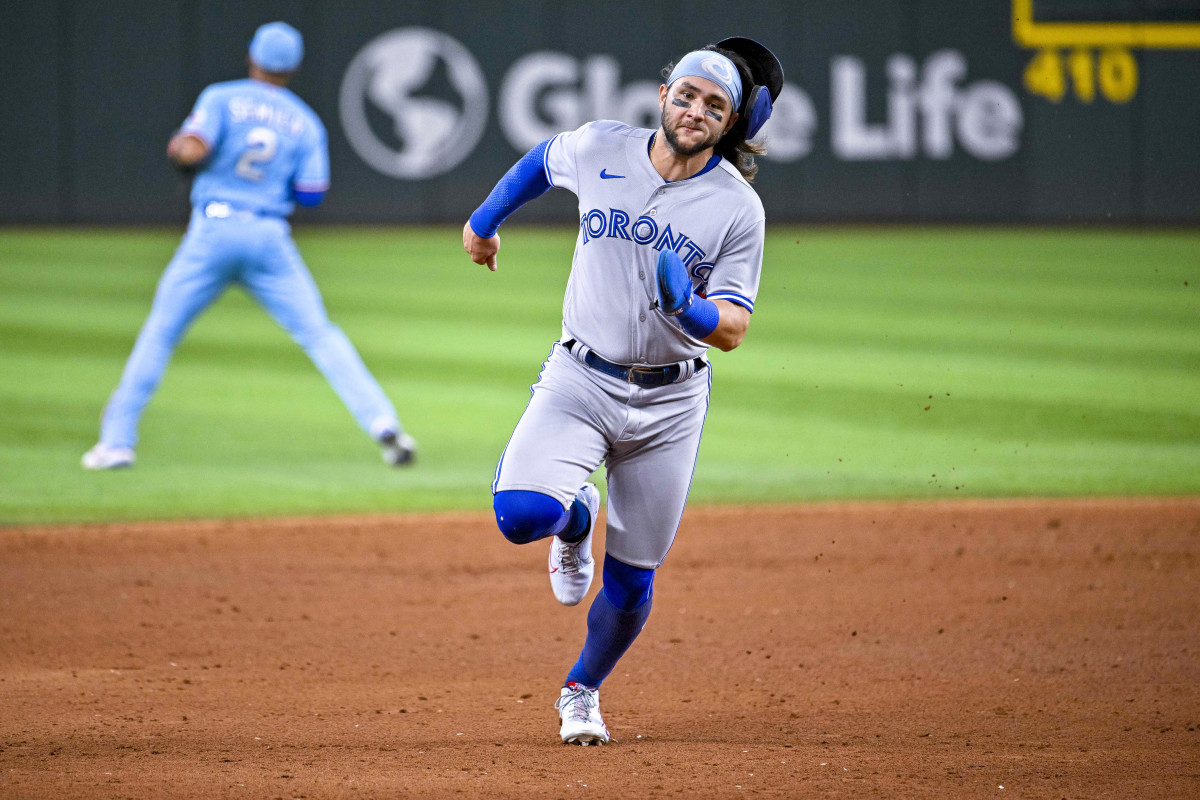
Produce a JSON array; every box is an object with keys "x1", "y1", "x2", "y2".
[{"x1": 338, "y1": 28, "x2": 488, "y2": 180}]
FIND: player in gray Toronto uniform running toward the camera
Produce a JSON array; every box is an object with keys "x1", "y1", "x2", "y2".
[{"x1": 463, "y1": 37, "x2": 784, "y2": 745}]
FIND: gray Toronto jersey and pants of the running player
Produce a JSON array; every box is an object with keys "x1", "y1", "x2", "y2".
[{"x1": 492, "y1": 121, "x2": 764, "y2": 569}]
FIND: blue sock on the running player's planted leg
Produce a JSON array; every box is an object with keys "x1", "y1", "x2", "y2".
[{"x1": 566, "y1": 555, "x2": 654, "y2": 687}]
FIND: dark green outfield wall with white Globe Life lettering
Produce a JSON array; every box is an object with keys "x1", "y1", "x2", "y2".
[{"x1": 0, "y1": 0, "x2": 1200, "y2": 224}]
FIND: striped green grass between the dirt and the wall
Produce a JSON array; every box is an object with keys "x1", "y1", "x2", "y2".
[{"x1": 0, "y1": 227, "x2": 1200, "y2": 523}]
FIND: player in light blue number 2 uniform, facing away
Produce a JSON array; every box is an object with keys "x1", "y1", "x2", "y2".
[{"x1": 83, "y1": 22, "x2": 416, "y2": 469}]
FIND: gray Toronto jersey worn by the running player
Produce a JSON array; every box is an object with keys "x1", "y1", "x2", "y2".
[{"x1": 546, "y1": 121, "x2": 766, "y2": 365}]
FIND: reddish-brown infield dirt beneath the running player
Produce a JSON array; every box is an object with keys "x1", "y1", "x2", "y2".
[{"x1": 0, "y1": 499, "x2": 1200, "y2": 800}]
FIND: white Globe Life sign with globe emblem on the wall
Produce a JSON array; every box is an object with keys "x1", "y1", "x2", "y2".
[{"x1": 340, "y1": 28, "x2": 1024, "y2": 181}]
